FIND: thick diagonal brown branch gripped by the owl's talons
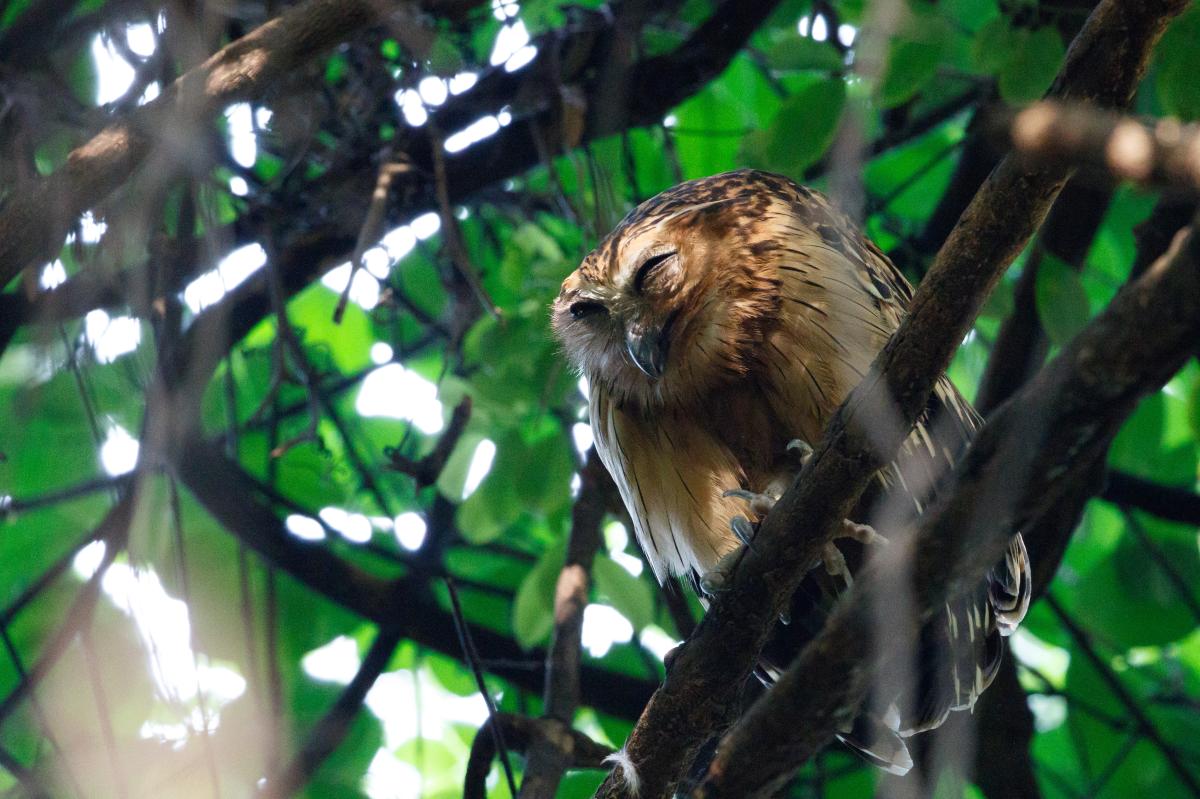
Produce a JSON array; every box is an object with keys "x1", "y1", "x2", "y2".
[{"x1": 599, "y1": 0, "x2": 1187, "y2": 797}]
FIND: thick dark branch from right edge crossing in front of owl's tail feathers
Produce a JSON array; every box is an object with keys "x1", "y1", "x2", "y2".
[{"x1": 700, "y1": 203, "x2": 1200, "y2": 797}]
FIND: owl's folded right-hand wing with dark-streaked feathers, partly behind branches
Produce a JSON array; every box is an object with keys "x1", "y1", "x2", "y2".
[{"x1": 764, "y1": 196, "x2": 1031, "y2": 770}]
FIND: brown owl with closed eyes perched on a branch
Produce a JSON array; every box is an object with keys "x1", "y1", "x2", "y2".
[{"x1": 551, "y1": 169, "x2": 1031, "y2": 773}]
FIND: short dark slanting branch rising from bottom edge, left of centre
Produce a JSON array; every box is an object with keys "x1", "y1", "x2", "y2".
[{"x1": 259, "y1": 624, "x2": 402, "y2": 799}]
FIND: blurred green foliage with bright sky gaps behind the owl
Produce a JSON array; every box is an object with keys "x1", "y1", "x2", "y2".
[{"x1": 0, "y1": 0, "x2": 1200, "y2": 799}]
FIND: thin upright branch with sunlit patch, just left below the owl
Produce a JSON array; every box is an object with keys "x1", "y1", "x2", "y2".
[{"x1": 521, "y1": 447, "x2": 607, "y2": 799}]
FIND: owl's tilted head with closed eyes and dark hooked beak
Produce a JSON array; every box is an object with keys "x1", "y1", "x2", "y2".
[{"x1": 552, "y1": 170, "x2": 805, "y2": 410}]
